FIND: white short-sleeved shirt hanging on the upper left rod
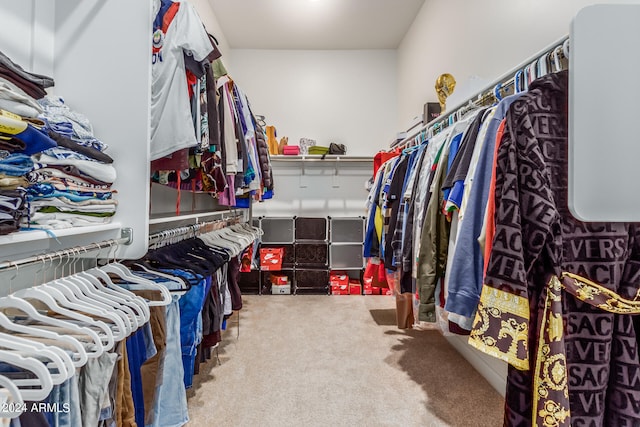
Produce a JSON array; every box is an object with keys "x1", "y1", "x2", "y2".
[{"x1": 151, "y1": 0, "x2": 213, "y2": 160}]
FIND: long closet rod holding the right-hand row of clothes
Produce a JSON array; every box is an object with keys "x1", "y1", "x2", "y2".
[{"x1": 391, "y1": 36, "x2": 569, "y2": 149}]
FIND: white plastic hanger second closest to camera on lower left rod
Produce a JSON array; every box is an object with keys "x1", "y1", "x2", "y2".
[{"x1": 0, "y1": 350, "x2": 53, "y2": 402}]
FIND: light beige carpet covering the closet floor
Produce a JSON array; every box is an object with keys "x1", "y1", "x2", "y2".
[{"x1": 188, "y1": 295, "x2": 503, "y2": 427}]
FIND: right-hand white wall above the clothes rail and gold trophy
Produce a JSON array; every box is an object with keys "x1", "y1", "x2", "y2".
[{"x1": 396, "y1": 0, "x2": 638, "y2": 130}]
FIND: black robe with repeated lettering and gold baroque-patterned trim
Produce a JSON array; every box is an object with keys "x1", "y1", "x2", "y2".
[{"x1": 469, "y1": 72, "x2": 640, "y2": 426}]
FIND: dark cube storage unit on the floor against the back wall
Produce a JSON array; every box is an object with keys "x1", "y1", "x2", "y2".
[{"x1": 240, "y1": 217, "x2": 364, "y2": 295}]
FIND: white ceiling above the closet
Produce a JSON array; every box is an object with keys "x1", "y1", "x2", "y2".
[{"x1": 209, "y1": 0, "x2": 424, "y2": 49}]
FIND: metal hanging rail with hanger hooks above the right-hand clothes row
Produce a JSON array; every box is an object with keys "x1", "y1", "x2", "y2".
[{"x1": 391, "y1": 36, "x2": 569, "y2": 150}]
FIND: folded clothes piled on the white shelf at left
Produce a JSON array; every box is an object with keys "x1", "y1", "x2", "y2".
[{"x1": 0, "y1": 52, "x2": 117, "y2": 234}]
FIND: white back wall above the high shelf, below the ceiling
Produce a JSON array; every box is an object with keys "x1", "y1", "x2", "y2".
[{"x1": 225, "y1": 49, "x2": 396, "y2": 156}]
